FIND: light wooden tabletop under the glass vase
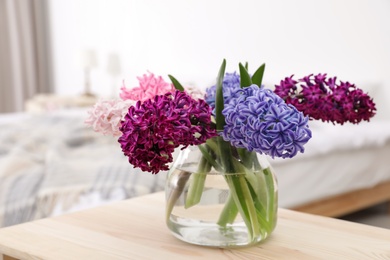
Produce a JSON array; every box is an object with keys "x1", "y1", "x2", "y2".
[{"x1": 0, "y1": 193, "x2": 390, "y2": 260}]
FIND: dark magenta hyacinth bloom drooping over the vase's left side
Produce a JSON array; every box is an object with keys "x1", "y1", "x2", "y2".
[{"x1": 118, "y1": 91, "x2": 216, "y2": 173}]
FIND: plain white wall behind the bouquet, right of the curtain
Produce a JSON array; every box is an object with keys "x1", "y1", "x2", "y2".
[{"x1": 50, "y1": 0, "x2": 390, "y2": 118}]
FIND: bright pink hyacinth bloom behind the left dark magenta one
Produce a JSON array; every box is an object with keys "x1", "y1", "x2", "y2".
[{"x1": 119, "y1": 72, "x2": 175, "y2": 102}]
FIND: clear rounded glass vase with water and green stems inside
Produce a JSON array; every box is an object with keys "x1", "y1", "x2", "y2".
[{"x1": 165, "y1": 137, "x2": 278, "y2": 247}]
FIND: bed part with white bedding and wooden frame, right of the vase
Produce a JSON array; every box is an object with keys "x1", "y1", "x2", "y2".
[{"x1": 272, "y1": 120, "x2": 390, "y2": 217}]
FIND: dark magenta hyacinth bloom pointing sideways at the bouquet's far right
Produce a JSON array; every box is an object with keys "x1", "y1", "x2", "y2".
[{"x1": 275, "y1": 74, "x2": 376, "y2": 124}]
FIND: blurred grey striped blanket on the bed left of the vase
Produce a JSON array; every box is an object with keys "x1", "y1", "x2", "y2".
[{"x1": 0, "y1": 113, "x2": 166, "y2": 227}]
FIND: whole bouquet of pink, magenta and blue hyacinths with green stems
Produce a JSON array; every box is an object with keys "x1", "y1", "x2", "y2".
[{"x1": 86, "y1": 60, "x2": 375, "y2": 247}]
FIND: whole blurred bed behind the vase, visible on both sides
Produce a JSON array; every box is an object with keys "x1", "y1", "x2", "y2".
[{"x1": 0, "y1": 110, "x2": 390, "y2": 226}]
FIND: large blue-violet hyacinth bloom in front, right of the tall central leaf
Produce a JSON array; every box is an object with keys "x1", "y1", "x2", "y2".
[{"x1": 221, "y1": 85, "x2": 311, "y2": 158}]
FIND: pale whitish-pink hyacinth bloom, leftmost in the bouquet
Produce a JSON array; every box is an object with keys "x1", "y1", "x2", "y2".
[{"x1": 85, "y1": 100, "x2": 135, "y2": 136}]
